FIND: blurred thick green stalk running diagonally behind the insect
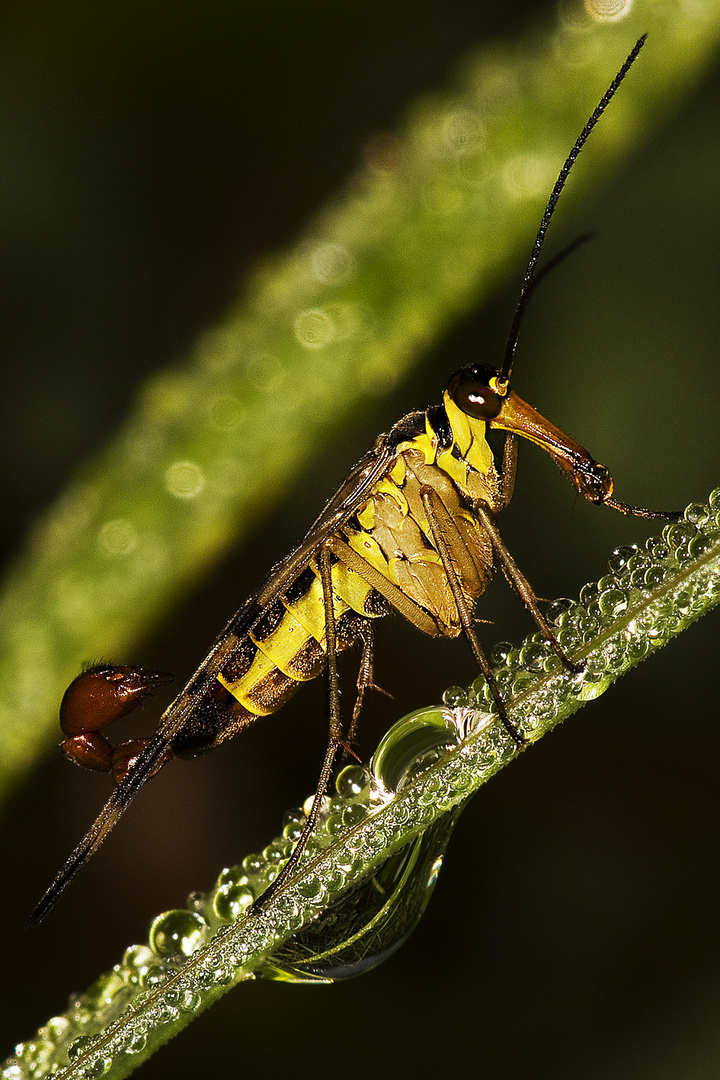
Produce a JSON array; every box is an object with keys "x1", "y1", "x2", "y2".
[{"x1": 0, "y1": 0, "x2": 720, "y2": 803}]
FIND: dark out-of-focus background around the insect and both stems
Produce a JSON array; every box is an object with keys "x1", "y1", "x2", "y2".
[{"x1": 0, "y1": 0, "x2": 720, "y2": 1080}]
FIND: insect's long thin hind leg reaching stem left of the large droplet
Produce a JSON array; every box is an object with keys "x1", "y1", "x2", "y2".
[{"x1": 250, "y1": 544, "x2": 347, "y2": 915}]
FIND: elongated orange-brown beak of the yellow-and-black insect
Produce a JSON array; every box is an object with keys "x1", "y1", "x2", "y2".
[{"x1": 488, "y1": 390, "x2": 612, "y2": 502}]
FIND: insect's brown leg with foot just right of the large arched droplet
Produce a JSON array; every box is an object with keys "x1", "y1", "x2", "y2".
[{"x1": 420, "y1": 484, "x2": 526, "y2": 746}]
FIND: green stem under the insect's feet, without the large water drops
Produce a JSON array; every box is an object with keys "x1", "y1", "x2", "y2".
[{"x1": 5, "y1": 489, "x2": 720, "y2": 1080}]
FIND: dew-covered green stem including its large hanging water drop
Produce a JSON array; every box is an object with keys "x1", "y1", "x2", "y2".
[{"x1": 5, "y1": 488, "x2": 720, "y2": 1080}]
